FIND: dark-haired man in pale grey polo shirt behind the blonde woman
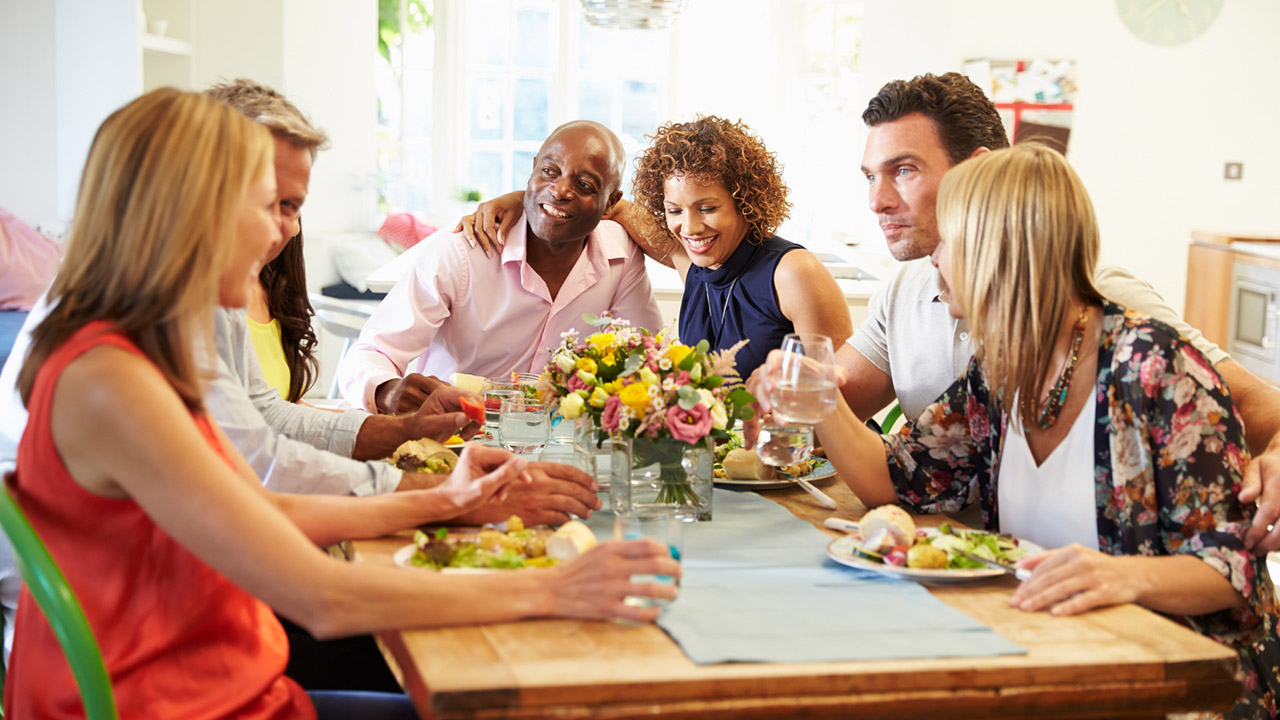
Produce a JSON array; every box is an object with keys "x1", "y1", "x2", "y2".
[{"x1": 836, "y1": 73, "x2": 1280, "y2": 552}]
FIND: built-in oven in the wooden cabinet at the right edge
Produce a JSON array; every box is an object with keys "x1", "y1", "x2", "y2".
[{"x1": 1228, "y1": 261, "x2": 1280, "y2": 383}]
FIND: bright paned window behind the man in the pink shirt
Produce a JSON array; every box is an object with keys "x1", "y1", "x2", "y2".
[{"x1": 375, "y1": 0, "x2": 671, "y2": 219}]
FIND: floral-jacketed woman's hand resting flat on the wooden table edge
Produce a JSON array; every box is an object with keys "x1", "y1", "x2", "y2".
[{"x1": 1009, "y1": 544, "x2": 1146, "y2": 615}]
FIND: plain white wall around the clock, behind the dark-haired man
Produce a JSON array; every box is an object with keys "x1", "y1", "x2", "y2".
[{"x1": 851, "y1": 0, "x2": 1280, "y2": 311}]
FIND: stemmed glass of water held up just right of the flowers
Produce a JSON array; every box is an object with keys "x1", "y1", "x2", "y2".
[{"x1": 756, "y1": 333, "x2": 838, "y2": 466}]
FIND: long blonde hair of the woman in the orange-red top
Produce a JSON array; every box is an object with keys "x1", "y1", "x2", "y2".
[{"x1": 18, "y1": 88, "x2": 273, "y2": 410}]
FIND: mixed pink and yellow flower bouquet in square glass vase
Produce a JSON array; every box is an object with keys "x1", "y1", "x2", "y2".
[{"x1": 539, "y1": 315, "x2": 755, "y2": 519}]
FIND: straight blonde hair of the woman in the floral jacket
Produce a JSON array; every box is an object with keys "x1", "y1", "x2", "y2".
[{"x1": 937, "y1": 143, "x2": 1102, "y2": 427}]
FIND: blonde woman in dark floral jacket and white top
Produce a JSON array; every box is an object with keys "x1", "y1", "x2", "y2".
[{"x1": 773, "y1": 146, "x2": 1280, "y2": 717}]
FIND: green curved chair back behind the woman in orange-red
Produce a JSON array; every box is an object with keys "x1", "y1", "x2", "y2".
[{"x1": 0, "y1": 473, "x2": 116, "y2": 720}]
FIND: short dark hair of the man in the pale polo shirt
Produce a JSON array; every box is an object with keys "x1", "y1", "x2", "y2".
[{"x1": 863, "y1": 73, "x2": 1009, "y2": 164}]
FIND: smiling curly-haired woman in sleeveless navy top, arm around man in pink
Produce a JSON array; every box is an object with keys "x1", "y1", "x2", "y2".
[{"x1": 460, "y1": 115, "x2": 852, "y2": 378}]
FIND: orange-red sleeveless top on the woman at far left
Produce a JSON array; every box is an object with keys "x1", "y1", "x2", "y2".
[{"x1": 4, "y1": 322, "x2": 316, "y2": 720}]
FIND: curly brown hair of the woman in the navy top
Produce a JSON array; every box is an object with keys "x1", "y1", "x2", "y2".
[{"x1": 631, "y1": 115, "x2": 791, "y2": 252}]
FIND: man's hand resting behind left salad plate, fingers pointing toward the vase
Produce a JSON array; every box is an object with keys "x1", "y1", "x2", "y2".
[{"x1": 456, "y1": 462, "x2": 600, "y2": 525}]
